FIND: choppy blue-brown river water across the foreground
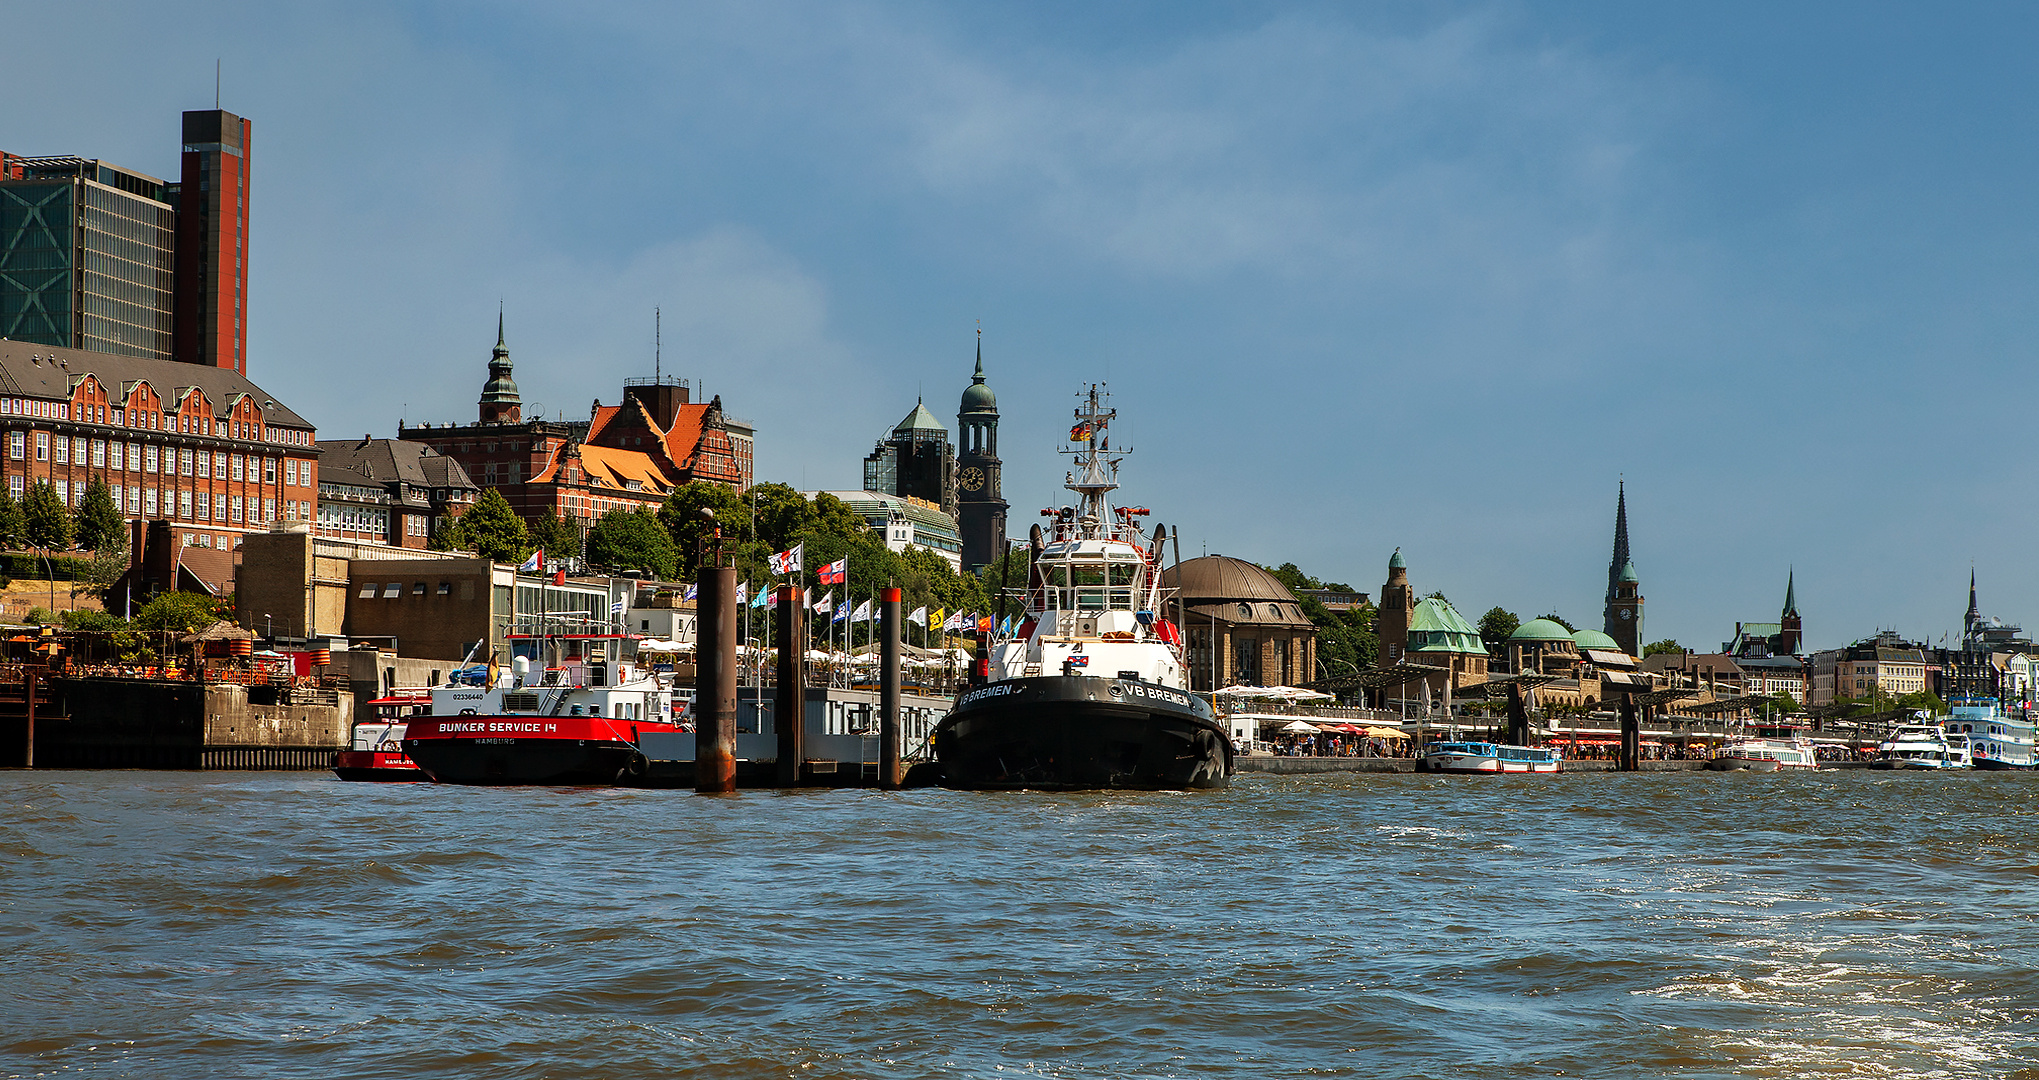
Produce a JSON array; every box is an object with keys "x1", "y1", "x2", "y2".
[{"x1": 0, "y1": 770, "x2": 2039, "y2": 1080}]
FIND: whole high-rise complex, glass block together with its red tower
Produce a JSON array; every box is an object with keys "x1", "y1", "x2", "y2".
[{"x1": 0, "y1": 110, "x2": 251, "y2": 375}]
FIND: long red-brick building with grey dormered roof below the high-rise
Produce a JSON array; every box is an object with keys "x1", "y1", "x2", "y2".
[{"x1": 0, "y1": 340, "x2": 318, "y2": 550}]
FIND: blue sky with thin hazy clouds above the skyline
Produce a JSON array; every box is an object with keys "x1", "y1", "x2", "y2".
[{"x1": 0, "y1": 0, "x2": 2039, "y2": 648}]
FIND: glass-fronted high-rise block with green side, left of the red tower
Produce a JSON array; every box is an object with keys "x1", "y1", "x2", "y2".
[{"x1": 0, "y1": 153, "x2": 177, "y2": 361}]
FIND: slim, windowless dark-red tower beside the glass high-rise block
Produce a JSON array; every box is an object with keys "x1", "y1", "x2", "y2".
[{"x1": 173, "y1": 108, "x2": 251, "y2": 375}]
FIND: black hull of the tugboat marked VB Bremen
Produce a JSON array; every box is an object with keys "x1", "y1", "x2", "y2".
[{"x1": 934, "y1": 677, "x2": 1232, "y2": 791}]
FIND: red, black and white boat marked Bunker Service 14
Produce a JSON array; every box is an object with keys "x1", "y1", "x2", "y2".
[{"x1": 404, "y1": 634, "x2": 687, "y2": 785}]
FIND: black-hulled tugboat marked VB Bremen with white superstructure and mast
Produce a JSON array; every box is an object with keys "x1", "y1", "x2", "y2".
[{"x1": 934, "y1": 385, "x2": 1232, "y2": 791}]
